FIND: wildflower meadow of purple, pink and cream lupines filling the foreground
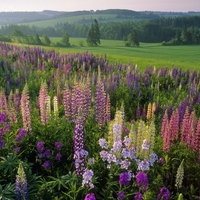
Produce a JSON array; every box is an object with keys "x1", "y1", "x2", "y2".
[{"x1": 0, "y1": 43, "x2": 200, "y2": 200}]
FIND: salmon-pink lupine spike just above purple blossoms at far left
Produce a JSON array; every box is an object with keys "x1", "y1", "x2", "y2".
[{"x1": 21, "y1": 84, "x2": 32, "y2": 132}]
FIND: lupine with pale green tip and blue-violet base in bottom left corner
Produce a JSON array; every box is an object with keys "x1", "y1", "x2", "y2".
[{"x1": 15, "y1": 163, "x2": 28, "y2": 200}]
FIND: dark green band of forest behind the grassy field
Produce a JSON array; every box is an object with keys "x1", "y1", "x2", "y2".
[{"x1": 0, "y1": 16, "x2": 200, "y2": 44}]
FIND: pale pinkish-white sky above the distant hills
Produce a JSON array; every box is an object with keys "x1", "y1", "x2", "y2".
[{"x1": 0, "y1": 0, "x2": 200, "y2": 12}]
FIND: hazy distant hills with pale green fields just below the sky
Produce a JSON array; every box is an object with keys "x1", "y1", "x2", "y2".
[{"x1": 0, "y1": 9, "x2": 200, "y2": 27}]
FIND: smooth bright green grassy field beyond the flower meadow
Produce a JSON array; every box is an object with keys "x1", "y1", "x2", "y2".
[{"x1": 42, "y1": 38, "x2": 200, "y2": 71}]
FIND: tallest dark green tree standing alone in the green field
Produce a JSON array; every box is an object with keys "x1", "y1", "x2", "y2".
[{"x1": 86, "y1": 19, "x2": 101, "y2": 46}]
